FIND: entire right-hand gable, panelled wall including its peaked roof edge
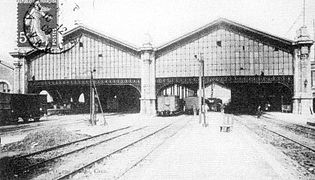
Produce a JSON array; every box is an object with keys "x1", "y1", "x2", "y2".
[{"x1": 155, "y1": 19, "x2": 294, "y2": 78}]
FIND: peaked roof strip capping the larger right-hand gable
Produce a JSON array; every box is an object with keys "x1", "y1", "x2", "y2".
[{"x1": 157, "y1": 18, "x2": 294, "y2": 51}]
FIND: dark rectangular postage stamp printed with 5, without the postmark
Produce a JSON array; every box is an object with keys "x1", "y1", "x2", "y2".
[{"x1": 17, "y1": 0, "x2": 58, "y2": 49}]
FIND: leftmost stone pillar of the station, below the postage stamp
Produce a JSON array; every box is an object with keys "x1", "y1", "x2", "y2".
[{"x1": 10, "y1": 50, "x2": 29, "y2": 94}]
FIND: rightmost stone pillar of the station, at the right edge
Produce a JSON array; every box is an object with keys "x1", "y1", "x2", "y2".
[{"x1": 293, "y1": 26, "x2": 313, "y2": 114}]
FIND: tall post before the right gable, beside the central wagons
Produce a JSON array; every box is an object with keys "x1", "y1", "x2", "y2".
[{"x1": 195, "y1": 53, "x2": 206, "y2": 126}]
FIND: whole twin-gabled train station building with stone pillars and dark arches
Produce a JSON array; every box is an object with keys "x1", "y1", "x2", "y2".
[{"x1": 11, "y1": 18, "x2": 313, "y2": 115}]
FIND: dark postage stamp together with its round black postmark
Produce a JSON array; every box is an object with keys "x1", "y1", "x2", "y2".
[{"x1": 17, "y1": 0, "x2": 80, "y2": 54}]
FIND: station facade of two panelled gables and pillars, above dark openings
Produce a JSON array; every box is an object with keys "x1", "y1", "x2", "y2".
[{"x1": 11, "y1": 19, "x2": 314, "y2": 114}]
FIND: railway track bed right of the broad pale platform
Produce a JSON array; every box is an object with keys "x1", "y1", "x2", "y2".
[{"x1": 236, "y1": 115, "x2": 315, "y2": 175}]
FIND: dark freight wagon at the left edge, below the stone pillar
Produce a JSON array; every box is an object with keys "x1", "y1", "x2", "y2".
[{"x1": 0, "y1": 93, "x2": 47, "y2": 125}]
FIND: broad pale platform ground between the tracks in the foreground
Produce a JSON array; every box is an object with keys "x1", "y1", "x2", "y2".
[{"x1": 124, "y1": 113, "x2": 302, "y2": 180}]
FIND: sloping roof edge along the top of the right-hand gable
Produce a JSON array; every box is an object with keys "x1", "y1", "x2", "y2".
[{"x1": 156, "y1": 18, "x2": 294, "y2": 51}]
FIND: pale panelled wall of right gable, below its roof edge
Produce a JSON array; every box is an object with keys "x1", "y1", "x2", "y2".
[{"x1": 156, "y1": 27, "x2": 293, "y2": 77}]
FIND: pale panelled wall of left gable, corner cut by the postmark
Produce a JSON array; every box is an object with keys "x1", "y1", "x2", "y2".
[{"x1": 29, "y1": 34, "x2": 141, "y2": 80}]
